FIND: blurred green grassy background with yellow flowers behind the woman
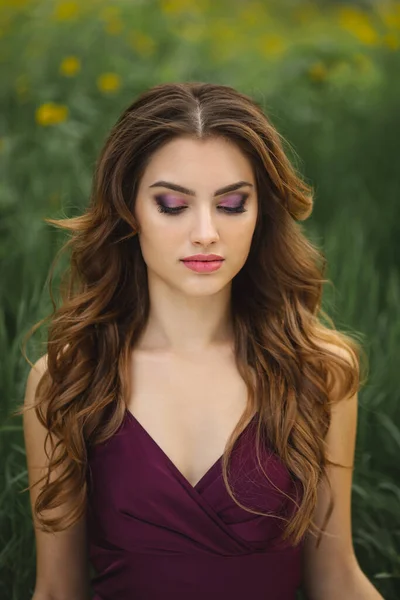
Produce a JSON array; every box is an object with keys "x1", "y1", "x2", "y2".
[{"x1": 0, "y1": 0, "x2": 400, "y2": 600}]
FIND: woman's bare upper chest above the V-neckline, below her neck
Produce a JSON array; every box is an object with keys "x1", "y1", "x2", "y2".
[{"x1": 127, "y1": 354, "x2": 247, "y2": 485}]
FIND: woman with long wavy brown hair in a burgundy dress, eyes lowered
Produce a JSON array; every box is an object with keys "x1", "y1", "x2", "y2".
[{"x1": 21, "y1": 83, "x2": 381, "y2": 600}]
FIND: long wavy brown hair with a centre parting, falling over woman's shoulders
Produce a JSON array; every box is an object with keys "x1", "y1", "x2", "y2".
[{"x1": 15, "y1": 82, "x2": 366, "y2": 545}]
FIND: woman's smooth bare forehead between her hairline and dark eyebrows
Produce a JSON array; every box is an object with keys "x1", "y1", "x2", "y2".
[{"x1": 142, "y1": 137, "x2": 254, "y2": 188}]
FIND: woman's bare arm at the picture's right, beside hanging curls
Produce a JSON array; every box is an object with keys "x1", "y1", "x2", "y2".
[{"x1": 302, "y1": 345, "x2": 384, "y2": 600}]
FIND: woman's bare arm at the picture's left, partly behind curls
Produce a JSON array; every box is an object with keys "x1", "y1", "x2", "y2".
[{"x1": 23, "y1": 355, "x2": 90, "y2": 600}]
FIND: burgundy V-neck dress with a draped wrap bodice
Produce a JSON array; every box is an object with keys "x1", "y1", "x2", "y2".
[{"x1": 87, "y1": 411, "x2": 304, "y2": 600}]
